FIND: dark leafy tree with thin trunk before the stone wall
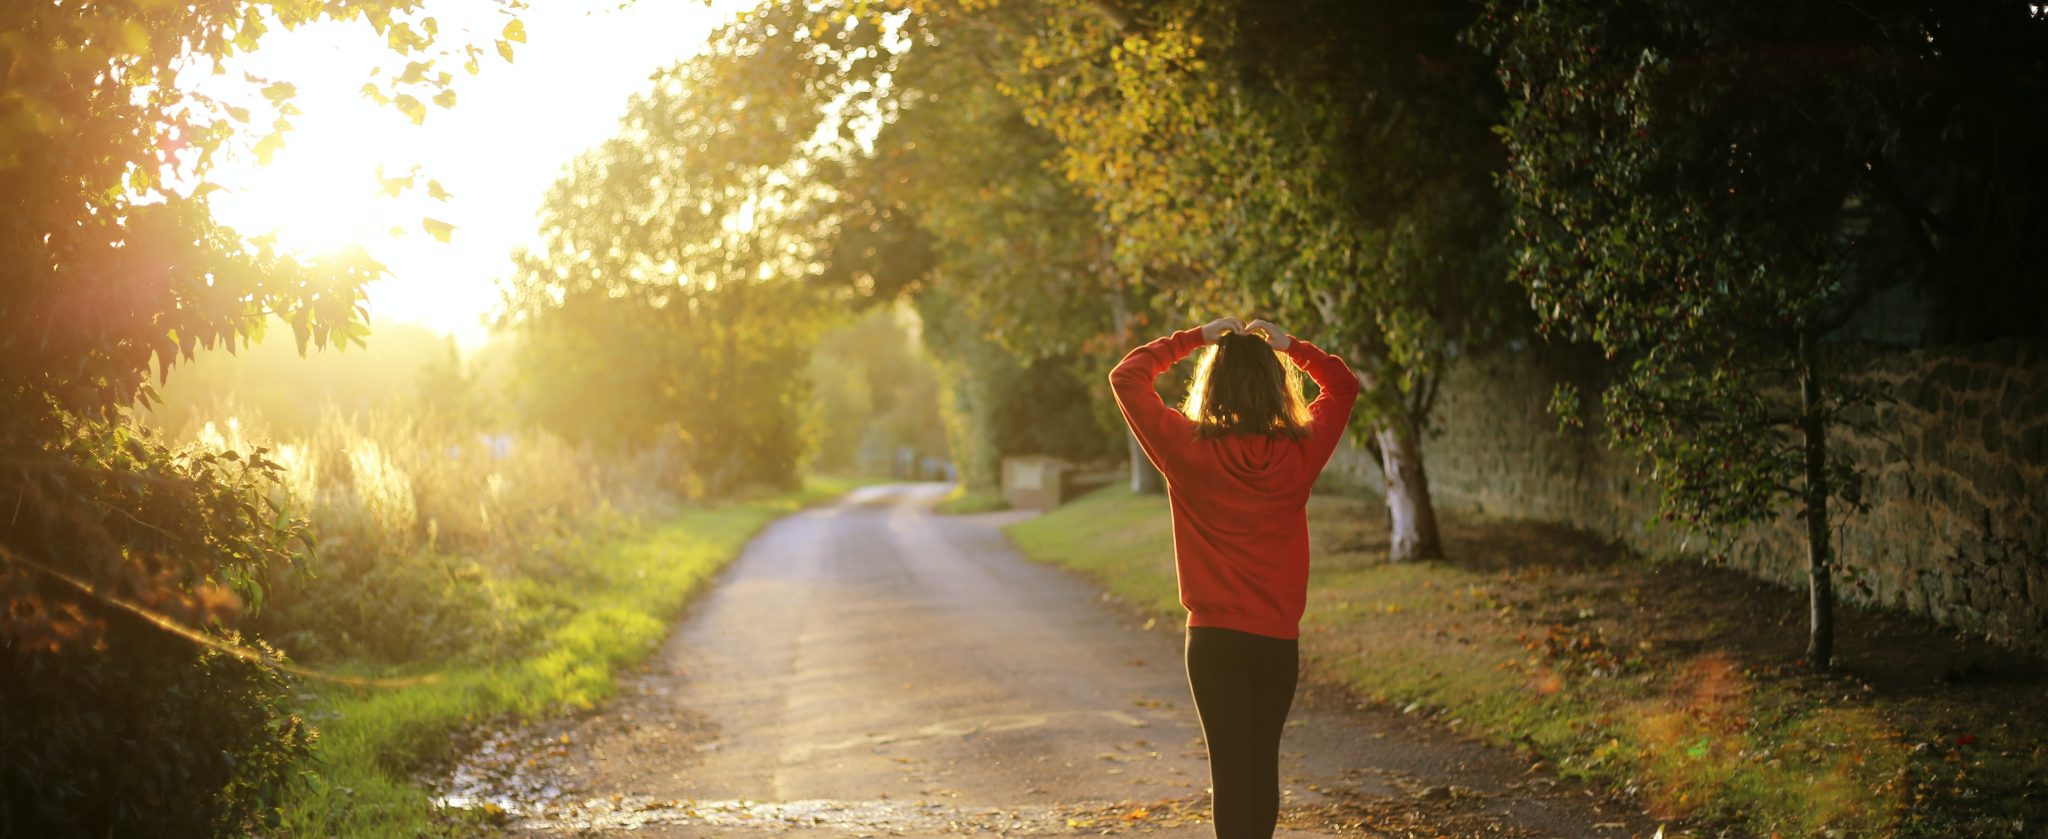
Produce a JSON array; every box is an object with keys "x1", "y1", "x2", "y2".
[{"x1": 1477, "y1": 2, "x2": 2048, "y2": 667}]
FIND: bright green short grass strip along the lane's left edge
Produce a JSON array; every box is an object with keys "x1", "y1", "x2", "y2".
[{"x1": 279, "y1": 479, "x2": 852, "y2": 837}]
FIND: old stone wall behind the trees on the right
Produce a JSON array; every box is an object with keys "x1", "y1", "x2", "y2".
[{"x1": 1337, "y1": 342, "x2": 2048, "y2": 653}]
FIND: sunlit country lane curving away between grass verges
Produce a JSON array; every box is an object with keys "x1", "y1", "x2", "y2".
[{"x1": 442, "y1": 485, "x2": 1651, "y2": 837}]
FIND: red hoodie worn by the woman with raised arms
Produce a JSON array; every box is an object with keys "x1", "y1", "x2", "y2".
[{"x1": 1110, "y1": 329, "x2": 1358, "y2": 638}]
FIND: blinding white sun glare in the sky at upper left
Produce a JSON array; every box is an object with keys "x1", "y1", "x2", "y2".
[{"x1": 195, "y1": 0, "x2": 748, "y2": 346}]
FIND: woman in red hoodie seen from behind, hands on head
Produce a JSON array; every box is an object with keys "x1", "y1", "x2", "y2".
[{"x1": 1110, "y1": 317, "x2": 1358, "y2": 839}]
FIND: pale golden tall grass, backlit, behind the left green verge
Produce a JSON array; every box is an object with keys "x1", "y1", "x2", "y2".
[{"x1": 173, "y1": 403, "x2": 678, "y2": 669}]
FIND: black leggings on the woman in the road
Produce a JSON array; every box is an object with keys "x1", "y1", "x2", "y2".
[{"x1": 1188, "y1": 626, "x2": 1300, "y2": 839}]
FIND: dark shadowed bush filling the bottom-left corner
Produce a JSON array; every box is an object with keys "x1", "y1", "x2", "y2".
[{"x1": 0, "y1": 411, "x2": 313, "y2": 837}]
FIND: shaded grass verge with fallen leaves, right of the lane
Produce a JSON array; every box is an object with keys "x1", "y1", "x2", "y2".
[{"x1": 1010, "y1": 489, "x2": 2048, "y2": 839}]
